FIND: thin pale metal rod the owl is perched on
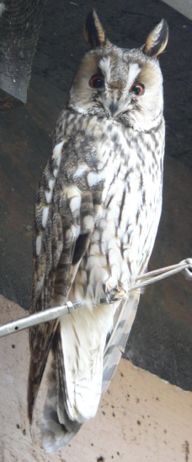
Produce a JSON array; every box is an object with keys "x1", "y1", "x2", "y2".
[{"x1": 0, "y1": 258, "x2": 192, "y2": 337}]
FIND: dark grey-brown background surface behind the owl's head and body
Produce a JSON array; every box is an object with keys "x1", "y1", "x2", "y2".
[{"x1": 0, "y1": 0, "x2": 192, "y2": 390}]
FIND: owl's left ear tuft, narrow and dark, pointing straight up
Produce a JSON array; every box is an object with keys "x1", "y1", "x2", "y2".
[{"x1": 85, "y1": 10, "x2": 106, "y2": 48}]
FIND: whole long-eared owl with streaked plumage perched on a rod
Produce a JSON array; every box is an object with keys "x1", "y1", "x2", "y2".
[{"x1": 28, "y1": 11, "x2": 168, "y2": 452}]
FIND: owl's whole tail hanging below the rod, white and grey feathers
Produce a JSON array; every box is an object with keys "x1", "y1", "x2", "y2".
[{"x1": 42, "y1": 294, "x2": 139, "y2": 452}]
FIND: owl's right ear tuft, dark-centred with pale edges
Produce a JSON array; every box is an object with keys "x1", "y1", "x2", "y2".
[{"x1": 143, "y1": 19, "x2": 169, "y2": 57}]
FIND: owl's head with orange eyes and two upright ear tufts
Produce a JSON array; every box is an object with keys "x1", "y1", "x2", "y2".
[{"x1": 69, "y1": 11, "x2": 168, "y2": 130}]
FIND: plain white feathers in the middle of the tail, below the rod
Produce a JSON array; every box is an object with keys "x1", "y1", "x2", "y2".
[{"x1": 60, "y1": 305, "x2": 115, "y2": 423}]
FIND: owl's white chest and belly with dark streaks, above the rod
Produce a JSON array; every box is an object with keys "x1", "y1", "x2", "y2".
[{"x1": 69, "y1": 113, "x2": 164, "y2": 298}]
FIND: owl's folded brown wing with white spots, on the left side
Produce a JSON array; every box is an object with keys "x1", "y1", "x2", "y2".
[{"x1": 28, "y1": 141, "x2": 98, "y2": 421}]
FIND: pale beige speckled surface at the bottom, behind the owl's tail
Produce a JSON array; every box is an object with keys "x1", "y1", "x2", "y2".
[{"x1": 0, "y1": 296, "x2": 192, "y2": 462}]
